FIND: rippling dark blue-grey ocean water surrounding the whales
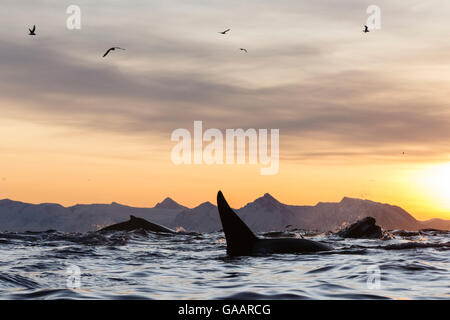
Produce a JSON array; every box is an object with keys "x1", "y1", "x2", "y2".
[{"x1": 0, "y1": 231, "x2": 450, "y2": 299}]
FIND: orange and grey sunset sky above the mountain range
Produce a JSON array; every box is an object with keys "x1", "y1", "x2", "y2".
[{"x1": 0, "y1": 0, "x2": 450, "y2": 219}]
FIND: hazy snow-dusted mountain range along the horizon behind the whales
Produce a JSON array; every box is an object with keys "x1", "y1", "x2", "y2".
[{"x1": 0, "y1": 193, "x2": 450, "y2": 232}]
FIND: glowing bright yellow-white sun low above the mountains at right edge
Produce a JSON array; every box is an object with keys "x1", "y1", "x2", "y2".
[{"x1": 421, "y1": 162, "x2": 450, "y2": 211}]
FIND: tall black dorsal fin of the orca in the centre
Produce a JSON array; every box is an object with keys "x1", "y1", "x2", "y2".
[{"x1": 217, "y1": 191, "x2": 258, "y2": 255}]
